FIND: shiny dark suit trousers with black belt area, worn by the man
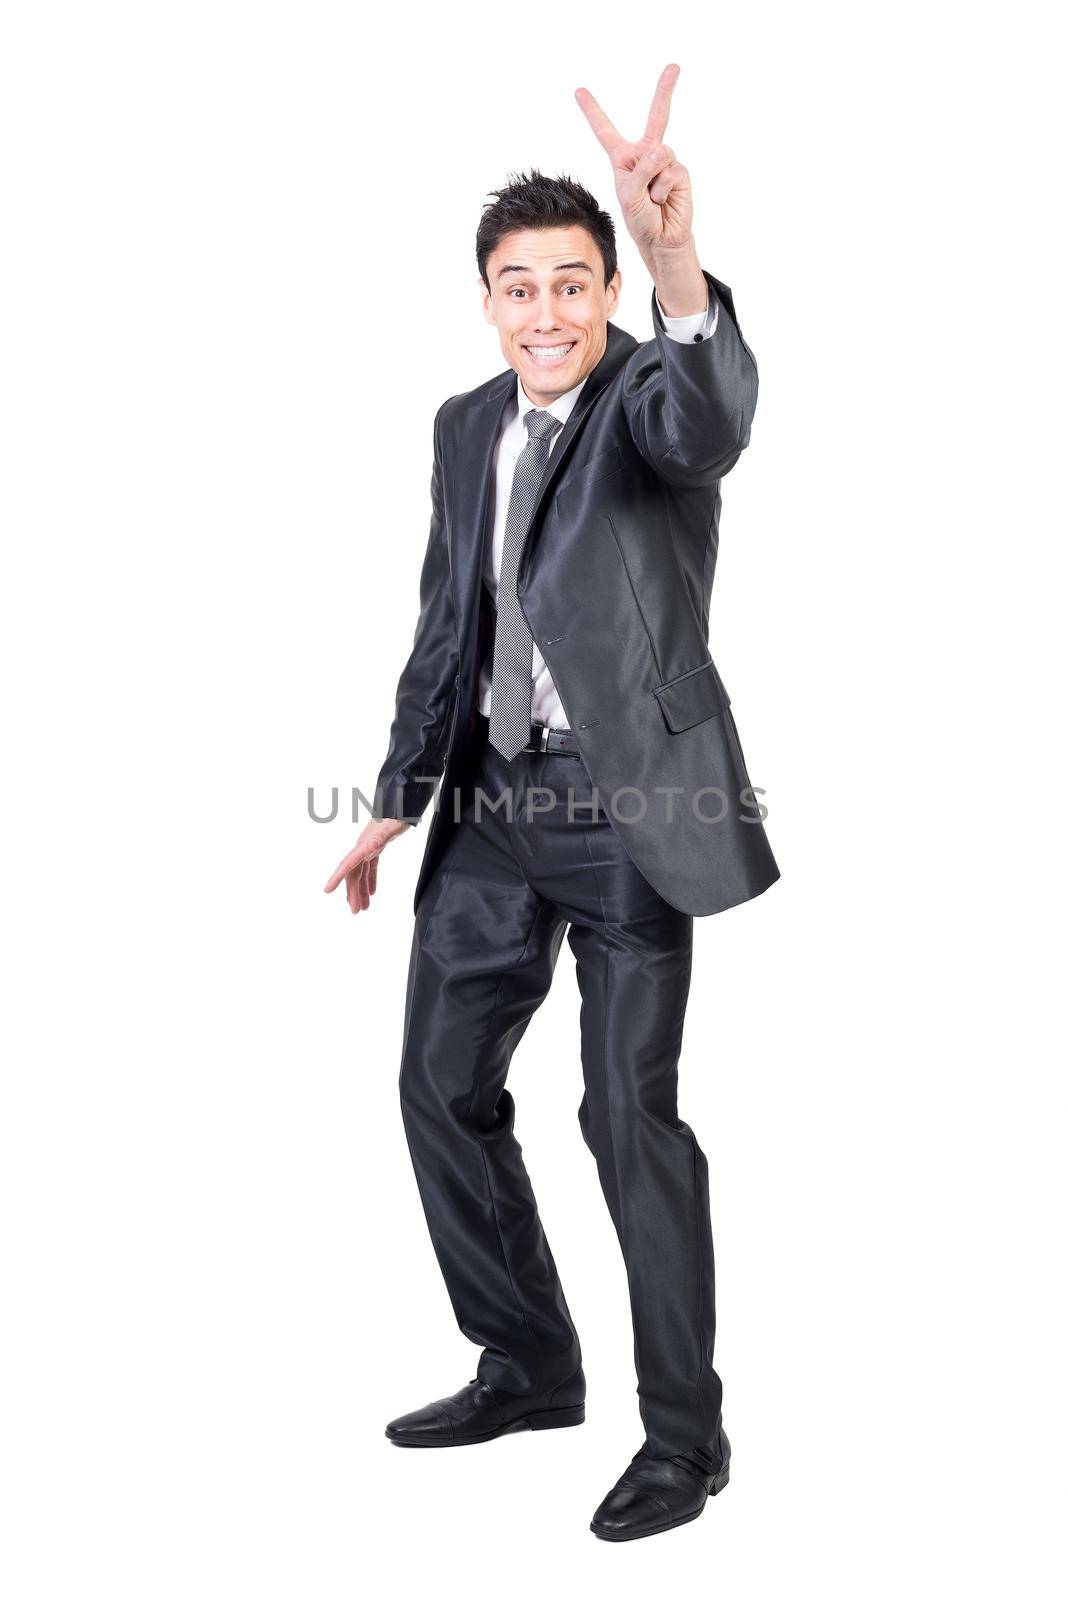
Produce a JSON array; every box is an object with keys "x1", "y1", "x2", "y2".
[{"x1": 400, "y1": 715, "x2": 721, "y2": 1454}]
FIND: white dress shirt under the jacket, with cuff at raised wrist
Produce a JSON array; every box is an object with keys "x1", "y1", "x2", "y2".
[{"x1": 478, "y1": 291, "x2": 719, "y2": 728}]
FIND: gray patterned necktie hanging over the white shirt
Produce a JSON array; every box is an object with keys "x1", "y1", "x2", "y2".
[{"x1": 489, "y1": 411, "x2": 563, "y2": 762}]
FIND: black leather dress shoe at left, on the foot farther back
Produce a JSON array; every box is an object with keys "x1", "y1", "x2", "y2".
[{"x1": 385, "y1": 1368, "x2": 585, "y2": 1446}]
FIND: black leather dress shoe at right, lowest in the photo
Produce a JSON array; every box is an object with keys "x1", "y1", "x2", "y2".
[{"x1": 590, "y1": 1430, "x2": 731, "y2": 1539}]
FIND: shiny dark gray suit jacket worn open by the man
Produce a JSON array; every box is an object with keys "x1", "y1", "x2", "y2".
[{"x1": 374, "y1": 272, "x2": 779, "y2": 917}]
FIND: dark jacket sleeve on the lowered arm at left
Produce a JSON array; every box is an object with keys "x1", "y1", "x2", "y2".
[{"x1": 374, "y1": 406, "x2": 459, "y2": 824}]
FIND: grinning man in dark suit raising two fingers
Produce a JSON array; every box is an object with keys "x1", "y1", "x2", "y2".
[{"x1": 326, "y1": 66, "x2": 779, "y2": 1539}]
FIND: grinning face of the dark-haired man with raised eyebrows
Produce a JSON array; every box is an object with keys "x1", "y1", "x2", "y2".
[{"x1": 480, "y1": 227, "x2": 622, "y2": 406}]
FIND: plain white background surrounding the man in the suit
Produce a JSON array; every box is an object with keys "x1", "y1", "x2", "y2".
[{"x1": 0, "y1": 0, "x2": 1065, "y2": 1600}]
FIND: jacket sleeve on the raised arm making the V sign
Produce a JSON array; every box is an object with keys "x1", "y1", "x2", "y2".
[{"x1": 622, "y1": 269, "x2": 756, "y2": 488}]
